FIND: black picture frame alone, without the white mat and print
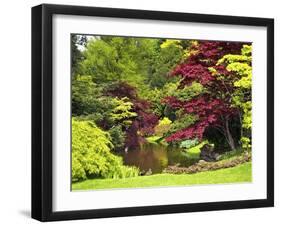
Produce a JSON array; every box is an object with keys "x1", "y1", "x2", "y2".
[{"x1": 32, "y1": 4, "x2": 274, "y2": 221}]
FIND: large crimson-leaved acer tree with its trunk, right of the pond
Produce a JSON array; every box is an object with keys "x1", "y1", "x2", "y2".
[{"x1": 163, "y1": 41, "x2": 249, "y2": 150}]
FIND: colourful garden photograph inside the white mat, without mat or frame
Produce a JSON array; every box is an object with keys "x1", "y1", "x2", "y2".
[{"x1": 70, "y1": 34, "x2": 252, "y2": 191}]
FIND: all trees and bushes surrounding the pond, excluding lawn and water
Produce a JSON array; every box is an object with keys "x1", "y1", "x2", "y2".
[{"x1": 71, "y1": 35, "x2": 252, "y2": 181}]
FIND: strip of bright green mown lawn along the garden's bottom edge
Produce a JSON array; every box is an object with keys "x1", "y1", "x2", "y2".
[{"x1": 72, "y1": 162, "x2": 252, "y2": 190}]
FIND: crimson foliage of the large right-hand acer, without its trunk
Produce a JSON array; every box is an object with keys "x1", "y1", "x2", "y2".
[{"x1": 163, "y1": 41, "x2": 243, "y2": 142}]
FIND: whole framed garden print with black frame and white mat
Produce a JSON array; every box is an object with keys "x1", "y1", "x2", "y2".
[{"x1": 32, "y1": 4, "x2": 274, "y2": 221}]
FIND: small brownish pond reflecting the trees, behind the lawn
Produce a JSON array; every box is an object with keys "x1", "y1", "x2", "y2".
[{"x1": 121, "y1": 143, "x2": 198, "y2": 174}]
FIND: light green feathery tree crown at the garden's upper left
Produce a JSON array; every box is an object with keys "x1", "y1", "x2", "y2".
[{"x1": 79, "y1": 37, "x2": 160, "y2": 96}]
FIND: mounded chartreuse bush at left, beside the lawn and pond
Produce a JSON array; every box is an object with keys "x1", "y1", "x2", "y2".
[{"x1": 72, "y1": 118, "x2": 139, "y2": 182}]
